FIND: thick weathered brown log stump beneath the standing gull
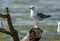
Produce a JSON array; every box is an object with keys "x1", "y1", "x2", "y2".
[{"x1": 21, "y1": 26, "x2": 43, "y2": 41}]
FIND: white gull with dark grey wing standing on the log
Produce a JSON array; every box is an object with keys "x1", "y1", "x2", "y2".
[{"x1": 29, "y1": 5, "x2": 51, "y2": 25}]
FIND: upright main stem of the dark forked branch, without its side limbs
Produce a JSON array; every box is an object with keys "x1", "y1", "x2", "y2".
[{"x1": 6, "y1": 7, "x2": 19, "y2": 41}]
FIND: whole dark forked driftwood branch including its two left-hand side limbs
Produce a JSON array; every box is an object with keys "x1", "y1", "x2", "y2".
[{"x1": 0, "y1": 7, "x2": 19, "y2": 41}]
